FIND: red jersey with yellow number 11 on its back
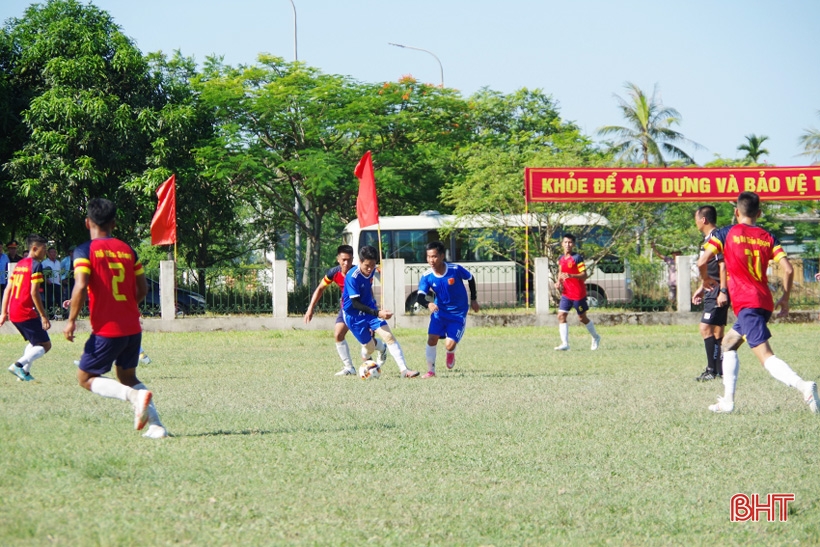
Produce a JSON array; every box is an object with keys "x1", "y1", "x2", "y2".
[{"x1": 703, "y1": 224, "x2": 786, "y2": 315}]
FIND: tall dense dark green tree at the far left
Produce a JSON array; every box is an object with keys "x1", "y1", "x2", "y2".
[{"x1": 5, "y1": 0, "x2": 157, "y2": 246}]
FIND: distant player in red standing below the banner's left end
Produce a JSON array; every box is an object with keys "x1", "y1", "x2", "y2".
[{"x1": 555, "y1": 233, "x2": 601, "y2": 351}]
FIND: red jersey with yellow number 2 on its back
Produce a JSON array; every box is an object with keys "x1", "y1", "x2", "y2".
[{"x1": 74, "y1": 237, "x2": 144, "y2": 338}]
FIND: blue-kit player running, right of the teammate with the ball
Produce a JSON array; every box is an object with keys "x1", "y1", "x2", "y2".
[{"x1": 418, "y1": 241, "x2": 480, "y2": 378}]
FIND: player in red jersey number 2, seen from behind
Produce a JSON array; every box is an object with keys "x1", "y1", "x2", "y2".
[{"x1": 63, "y1": 198, "x2": 168, "y2": 439}]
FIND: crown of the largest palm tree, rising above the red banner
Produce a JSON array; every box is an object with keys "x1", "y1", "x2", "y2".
[{"x1": 598, "y1": 82, "x2": 703, "y2": 167}]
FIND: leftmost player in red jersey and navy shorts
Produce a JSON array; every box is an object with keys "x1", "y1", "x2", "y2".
[{"x1": 0, "y1": 234, "x2": 51, "y2": 382}]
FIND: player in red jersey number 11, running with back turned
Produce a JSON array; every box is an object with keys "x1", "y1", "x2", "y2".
[{"x1": 698, "y1": 192, "x2": 818, "y2": 413}]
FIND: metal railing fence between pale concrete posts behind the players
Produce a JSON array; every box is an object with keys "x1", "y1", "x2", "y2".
[{"x1": 49, "y1": 258, "x2": 820, "y2": 319}]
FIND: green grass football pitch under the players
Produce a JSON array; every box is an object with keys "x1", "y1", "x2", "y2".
[{"x1": 0, "y1": 323, "x2": 820, "y2": 546}]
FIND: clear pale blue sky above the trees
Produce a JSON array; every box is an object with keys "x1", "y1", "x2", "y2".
[{"x1": 0, "y1": 0, "x2": 820, "y2": 166}]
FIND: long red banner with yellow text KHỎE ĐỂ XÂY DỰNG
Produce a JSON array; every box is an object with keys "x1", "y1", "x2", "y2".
[{"x1": 524, "y1": 167, "x2": 820, "y2": 202}]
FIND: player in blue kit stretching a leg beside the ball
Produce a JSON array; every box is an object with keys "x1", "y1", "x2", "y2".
[{"x1": 342, "y1": 245, "x2": 419, "y2": 378}]
